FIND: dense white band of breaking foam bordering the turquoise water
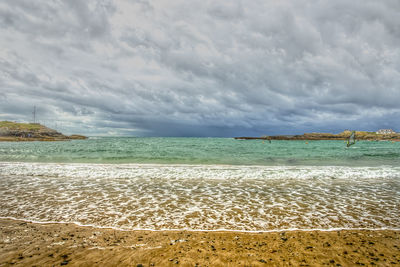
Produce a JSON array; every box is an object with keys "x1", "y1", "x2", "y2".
[{"x1": 0, "y1": 162, "x2": 400, "y2": 180}]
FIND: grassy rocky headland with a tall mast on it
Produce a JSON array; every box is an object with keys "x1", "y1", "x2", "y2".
[{"x1": 0, "y1": 121, "x2": 87, "y2": 141}]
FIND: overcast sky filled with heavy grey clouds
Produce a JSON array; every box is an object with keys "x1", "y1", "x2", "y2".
[{"x1": 0, "y1": 0, "x2": 400, "y2": 137}]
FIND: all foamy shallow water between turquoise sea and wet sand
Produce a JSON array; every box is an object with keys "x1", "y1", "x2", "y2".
[{"x1": 0, "y1": 163, "x2": 400, "y2": 231}]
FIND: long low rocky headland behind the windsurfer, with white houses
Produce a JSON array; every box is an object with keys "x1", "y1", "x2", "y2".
[{"x1": 235, "y1": 130, "x2": 400, "y2": 141}]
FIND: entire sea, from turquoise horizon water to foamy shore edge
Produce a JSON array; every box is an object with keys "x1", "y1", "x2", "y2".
[{"x1": 0, "y1": 137, "x2": 400, "y2": 232}]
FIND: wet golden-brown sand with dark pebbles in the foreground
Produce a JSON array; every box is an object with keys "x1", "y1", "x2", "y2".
[{"x1": 0, "y1": 219, "x2": 400, "y2": 266}]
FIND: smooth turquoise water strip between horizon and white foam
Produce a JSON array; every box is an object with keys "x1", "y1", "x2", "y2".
[{"x1": 0, "y1": 138, "x2": 400, "y2": 166}]
